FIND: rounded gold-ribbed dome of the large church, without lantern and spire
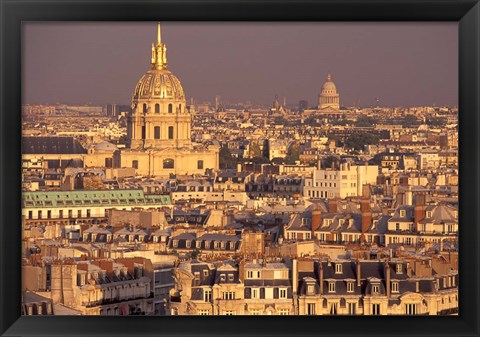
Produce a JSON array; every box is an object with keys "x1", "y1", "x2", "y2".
[{"x1": 132, "y1": 69, "x2": 185, "y2": 100}]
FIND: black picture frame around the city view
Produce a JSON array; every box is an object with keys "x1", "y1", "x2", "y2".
[{"x1": 0, "y1": 0, "x2": 480, "y2": 337}]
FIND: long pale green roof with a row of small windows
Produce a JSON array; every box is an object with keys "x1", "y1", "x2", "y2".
[{"x1": 22, "y1": 190, "x2": 172, "y2": 208}]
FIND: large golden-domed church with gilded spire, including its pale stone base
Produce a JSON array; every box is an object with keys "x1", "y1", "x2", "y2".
[{"x1": 121, "y1": 23, "x2": 219, "y2": 176}]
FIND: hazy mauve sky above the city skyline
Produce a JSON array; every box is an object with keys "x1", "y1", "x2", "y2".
[{"x1": 23, "y1": 22, "x2": 458, "y2": 106}]
